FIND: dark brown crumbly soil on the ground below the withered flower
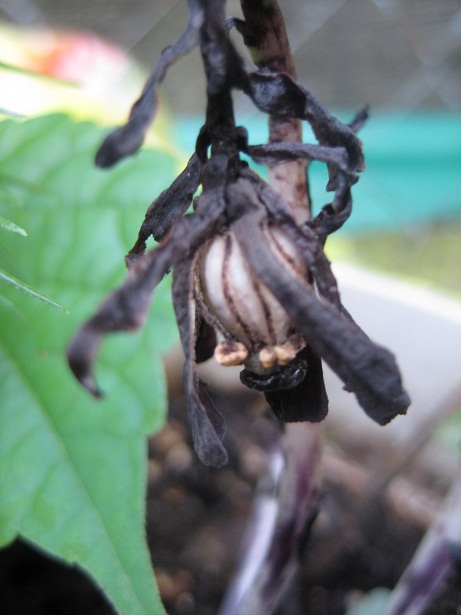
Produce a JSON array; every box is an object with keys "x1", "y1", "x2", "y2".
[{"x1": 0, "y1": 380, "x2": 461, "y2": 615}]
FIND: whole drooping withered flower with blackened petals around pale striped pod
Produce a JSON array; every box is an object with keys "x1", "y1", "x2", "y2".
[{"x1": 68, "y1": 0, "x2": 410, "y2": 466}]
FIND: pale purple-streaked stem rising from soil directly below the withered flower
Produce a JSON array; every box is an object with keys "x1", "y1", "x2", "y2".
[{"x1": 219, "y1": 423, "x2": 322, "y2": 615}]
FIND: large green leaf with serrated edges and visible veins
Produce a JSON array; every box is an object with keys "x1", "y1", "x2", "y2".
[{"x1": 0, "y1": 115, "x2": 179, "y2": 615}]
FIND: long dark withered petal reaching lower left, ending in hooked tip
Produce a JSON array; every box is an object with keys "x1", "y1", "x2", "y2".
[{"x1": 67, "y1": 156, "x2": 227, "y2": 396}]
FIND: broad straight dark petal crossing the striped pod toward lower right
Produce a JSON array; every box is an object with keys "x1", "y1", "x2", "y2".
[{"x1": 234, "y1": 212, "x2": 410, "y2": 425}]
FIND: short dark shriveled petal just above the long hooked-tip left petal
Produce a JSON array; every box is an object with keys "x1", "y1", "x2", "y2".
[{"x1": 125, "y1": 154, "x2": 201, "y2": 267}]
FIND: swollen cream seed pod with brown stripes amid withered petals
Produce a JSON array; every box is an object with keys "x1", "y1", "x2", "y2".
[{"x1": 197, "y1": 226, "x2": 307, "y2": 376}]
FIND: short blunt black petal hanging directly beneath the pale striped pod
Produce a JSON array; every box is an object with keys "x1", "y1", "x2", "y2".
[{"x1": 265, "y1": 346, "x2": 328, "y2": 423}]
